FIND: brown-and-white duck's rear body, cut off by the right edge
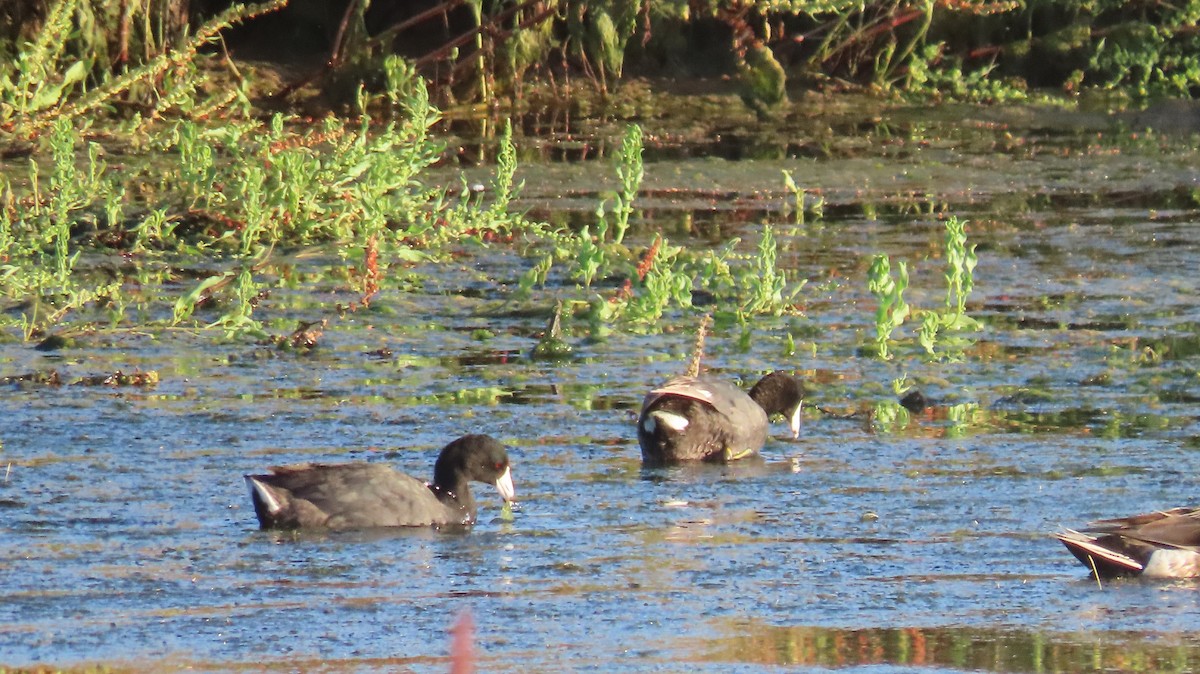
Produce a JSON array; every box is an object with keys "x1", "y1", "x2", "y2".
[{"x1": 1054, "y1": 507, "x2": 1200, "y2": 579}]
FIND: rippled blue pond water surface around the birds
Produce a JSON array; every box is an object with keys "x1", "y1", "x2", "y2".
[{"x1": 0, "y1": 97, "x2": 1200, "y2": 672}]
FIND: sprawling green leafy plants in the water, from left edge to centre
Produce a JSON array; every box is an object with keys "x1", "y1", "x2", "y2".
[{"x1": 0, "y1": 9, "x2": 803, "y2": 347}]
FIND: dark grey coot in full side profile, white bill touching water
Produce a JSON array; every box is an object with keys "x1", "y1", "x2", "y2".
[{"x1": 246, "y1": 435, "x2": 515, "y2": 529}]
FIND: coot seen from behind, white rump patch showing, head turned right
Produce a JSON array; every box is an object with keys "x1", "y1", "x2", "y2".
[{"x1": 637, "y1": 372, "x2": 804, "y2": 465}]
